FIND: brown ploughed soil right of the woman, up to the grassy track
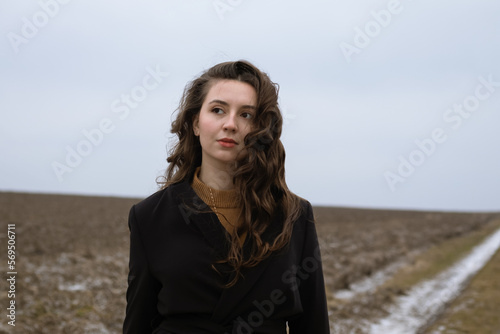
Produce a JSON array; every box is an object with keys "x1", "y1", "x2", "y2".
[{"x1": 315, "y1": 207, "x2": 498, "y2": 334}]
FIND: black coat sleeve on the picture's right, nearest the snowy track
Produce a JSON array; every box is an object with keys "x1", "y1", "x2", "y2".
[{"x1": 288, "y1": 203, "x2": 330, "y2": 334}]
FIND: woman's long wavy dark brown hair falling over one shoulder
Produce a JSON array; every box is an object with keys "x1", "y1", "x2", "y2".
[{"x1": 159, "y1": 61, "x2": 300, "y2": 286}]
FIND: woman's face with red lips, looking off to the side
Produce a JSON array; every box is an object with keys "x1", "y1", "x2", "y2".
[{"x1": 193, "y1": 80, "x2": 257, "y2": 168}]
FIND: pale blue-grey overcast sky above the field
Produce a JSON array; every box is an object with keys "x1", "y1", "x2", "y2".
[{"x1": 0, "y1": 0, "x2": 500, "y2": 211}]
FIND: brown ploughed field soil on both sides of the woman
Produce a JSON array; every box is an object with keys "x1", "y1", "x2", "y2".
[{"x1": 0, "y1": 193, "x2": 494, "y2": 334}]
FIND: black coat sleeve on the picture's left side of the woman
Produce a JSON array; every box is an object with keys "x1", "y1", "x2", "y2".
[{"x1": 123, "y1": 206, "x2": 160, "y2": 334}]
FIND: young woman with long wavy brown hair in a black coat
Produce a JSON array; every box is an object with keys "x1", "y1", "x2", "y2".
[{"x1": 123, "y1": 61, "x2": 330, "y2": 334}]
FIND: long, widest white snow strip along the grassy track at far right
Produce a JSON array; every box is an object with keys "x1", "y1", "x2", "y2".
[{"x1": 370, "y1": 229, "x2": 500, "y2": 334}]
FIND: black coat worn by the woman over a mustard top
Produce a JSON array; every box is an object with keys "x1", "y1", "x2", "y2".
[{"x1": 123, "y1": 182, "x2": 330, "y2": 334}]
